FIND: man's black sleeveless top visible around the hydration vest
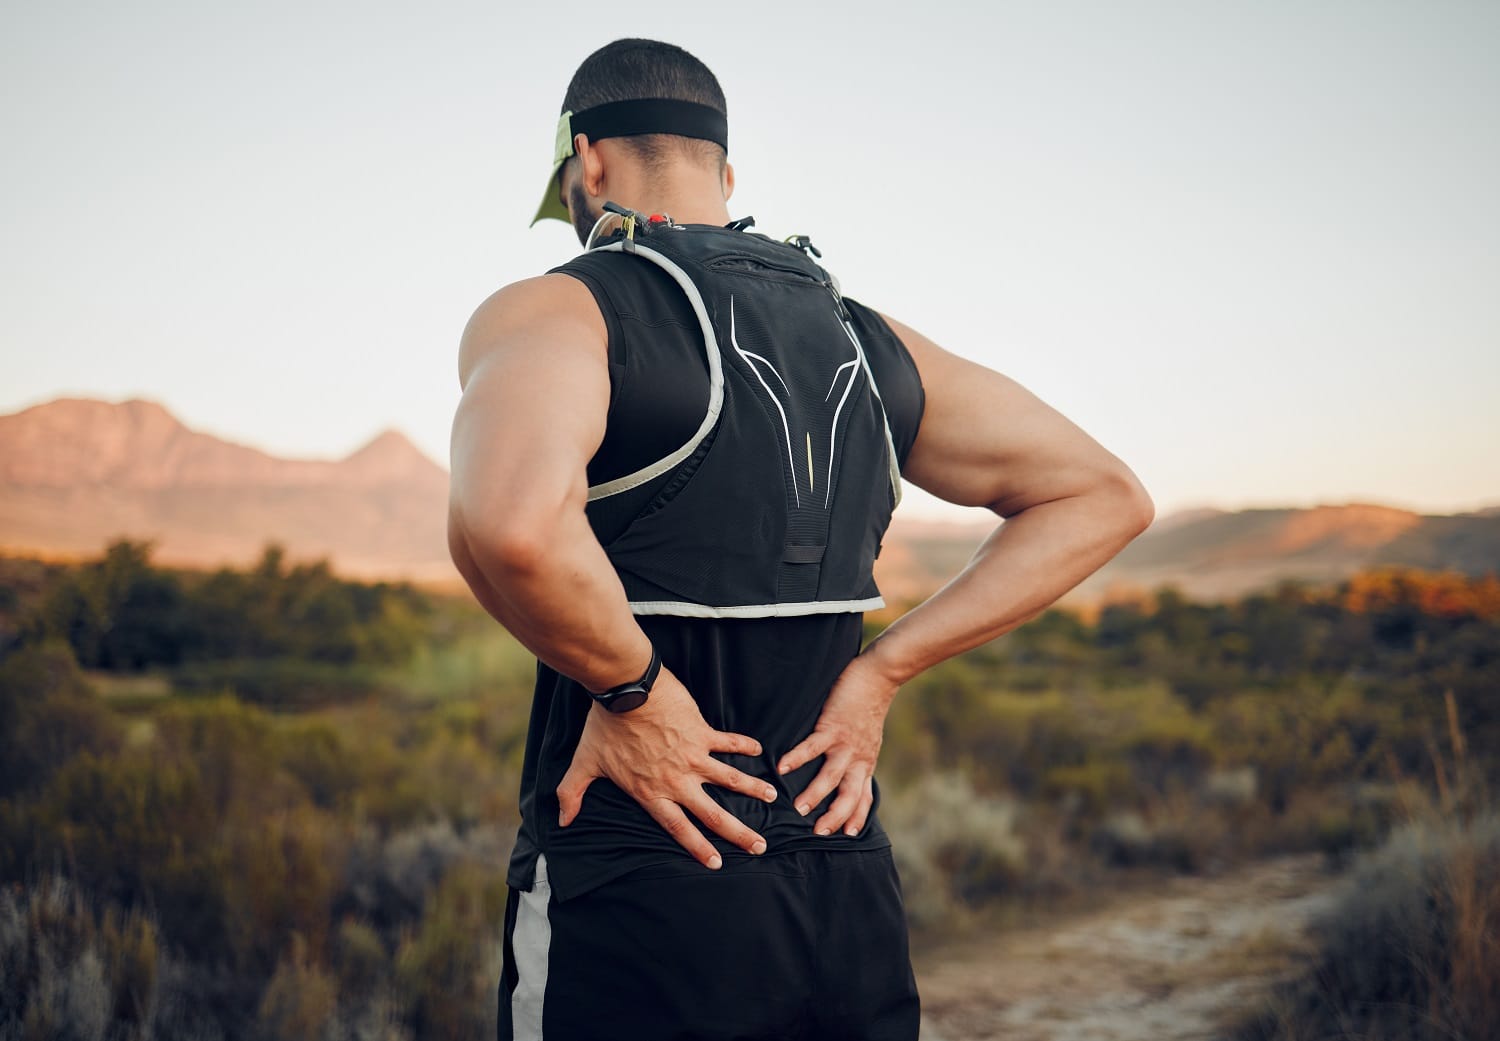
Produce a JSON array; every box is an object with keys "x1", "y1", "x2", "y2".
[{"x1": 507, "y1": 222, "x2": 924, "y2": 900}]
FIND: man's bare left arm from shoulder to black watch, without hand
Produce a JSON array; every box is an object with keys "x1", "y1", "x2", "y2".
[{"x1": 449, "y1": 275, "x2": 651, "y2": 690}]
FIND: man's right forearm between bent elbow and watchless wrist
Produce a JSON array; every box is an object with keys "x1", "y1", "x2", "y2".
[{"x1": 861, "y1": 488, "x2": 1143, "y2": 686}]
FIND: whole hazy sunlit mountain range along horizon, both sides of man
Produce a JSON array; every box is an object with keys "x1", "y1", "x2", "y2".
[{"x1": 0, "y1": 398, "x2": 1500, "y2": 605}]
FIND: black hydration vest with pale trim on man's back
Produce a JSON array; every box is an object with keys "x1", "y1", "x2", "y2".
[{"x1": 576, "y1": 215, "x2": 902, "y2": 618}]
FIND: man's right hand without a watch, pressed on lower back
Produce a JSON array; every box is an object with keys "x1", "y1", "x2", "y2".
[{"x1": 777, "y1": 656, "x2": 897, "y2": 836}]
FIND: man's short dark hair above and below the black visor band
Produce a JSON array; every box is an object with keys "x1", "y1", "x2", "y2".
[{"x1": 558, "y1": 36, "x2": 729, "y2": 171}]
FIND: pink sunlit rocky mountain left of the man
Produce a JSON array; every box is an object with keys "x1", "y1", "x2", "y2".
[{"x1": 0, "y1": 398, "x2": 458, "y2": 581}]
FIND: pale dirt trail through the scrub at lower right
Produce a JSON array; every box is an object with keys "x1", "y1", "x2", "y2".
[{"x1": 917, "y1": 855, "x2": 1338, "y2": 1041}]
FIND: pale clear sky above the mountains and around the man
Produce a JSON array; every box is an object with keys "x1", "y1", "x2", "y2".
[{"x1": 0, "y1": 0, "x2": 1500, "y2": 516}]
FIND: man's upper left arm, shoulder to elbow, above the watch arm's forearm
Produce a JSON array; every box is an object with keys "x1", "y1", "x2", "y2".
[{"x1": 450, "y1": 275, "x2": 609, "y2": 531}]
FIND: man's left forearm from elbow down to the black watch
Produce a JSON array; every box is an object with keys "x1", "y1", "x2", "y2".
[{"x1": 449, "y1": 510, "x2": 651, "y2": 690}]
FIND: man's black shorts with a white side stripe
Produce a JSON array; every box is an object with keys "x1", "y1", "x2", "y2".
[{"x1": 497, "y1": 849, "x2": 920, "y2": 1041}]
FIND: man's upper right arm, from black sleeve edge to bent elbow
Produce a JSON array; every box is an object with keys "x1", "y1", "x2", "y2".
[{"x1": 881, "y1": 314, "x2": 1128, "y2": 518}]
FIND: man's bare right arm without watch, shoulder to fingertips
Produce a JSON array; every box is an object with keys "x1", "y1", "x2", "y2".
[{"x1": 777, "y1": 314, "x2": 1155, "y2": 834}]
